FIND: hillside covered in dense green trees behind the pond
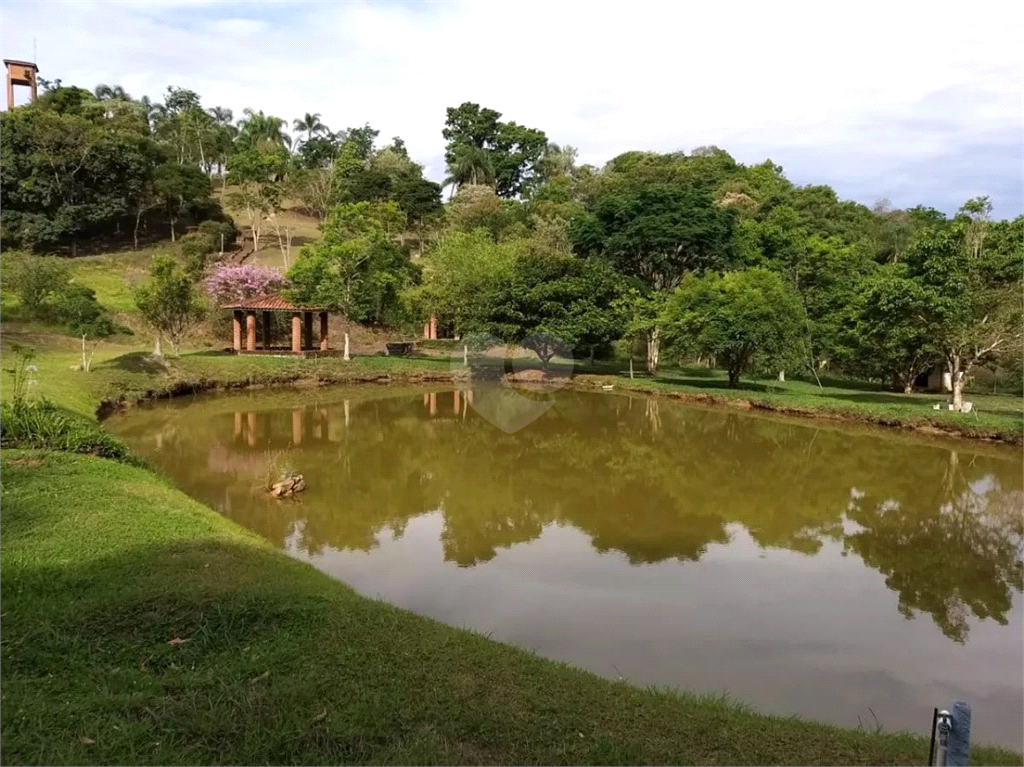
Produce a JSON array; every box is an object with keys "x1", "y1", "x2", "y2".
[{"x1": 0, "y1": 82, "x2": 1024, "y2": 409}]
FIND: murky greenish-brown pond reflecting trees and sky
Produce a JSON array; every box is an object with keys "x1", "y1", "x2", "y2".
[{"x1": 108, "y1": 386, "x2": 1024, "y2": 749}]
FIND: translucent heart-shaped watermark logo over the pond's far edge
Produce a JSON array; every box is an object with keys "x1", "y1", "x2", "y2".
[{"x1": 450, "y1": 334, "x2": 572, "y2": 434}]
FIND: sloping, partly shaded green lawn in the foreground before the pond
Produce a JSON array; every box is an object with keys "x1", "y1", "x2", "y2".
[{"x1": 0, "y1": 451, "x2": 1021, "y2": 764}]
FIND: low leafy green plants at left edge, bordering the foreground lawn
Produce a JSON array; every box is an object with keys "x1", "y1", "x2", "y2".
[{"x1": 0, "y1": 400, "x2": 144, "y2": 466}]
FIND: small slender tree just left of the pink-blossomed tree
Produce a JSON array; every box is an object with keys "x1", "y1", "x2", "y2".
[{"x1": 133, "y1": 256, "x2": 205, "y2": 357}]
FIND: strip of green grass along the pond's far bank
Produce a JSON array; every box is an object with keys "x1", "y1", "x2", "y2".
[{"x1": 0, "y1": 329, "x2": 1024, "y2": 444}]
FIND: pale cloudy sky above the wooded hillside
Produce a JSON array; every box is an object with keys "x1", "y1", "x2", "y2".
[{"x1": 6, "y1": 0, "x2": 1024, "y2": 218}]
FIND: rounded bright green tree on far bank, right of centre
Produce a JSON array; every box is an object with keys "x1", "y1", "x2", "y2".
[{"x1": 662, "y1": 268, "x2": 805, "y2": 388}]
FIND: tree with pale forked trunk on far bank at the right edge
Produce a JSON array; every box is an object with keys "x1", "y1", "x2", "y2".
[{"x1": 907, "y1": 221, "x2": 1024, "y2": 412}]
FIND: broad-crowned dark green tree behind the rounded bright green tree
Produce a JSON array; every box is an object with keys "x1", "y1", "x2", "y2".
[{"x1": 569, "y1": 182, "x2": 733, "y2": 373}]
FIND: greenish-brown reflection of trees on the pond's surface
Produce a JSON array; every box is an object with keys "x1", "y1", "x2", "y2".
[{"x1": 112, "y1": 388, "x2": 1024, "y2": 643}]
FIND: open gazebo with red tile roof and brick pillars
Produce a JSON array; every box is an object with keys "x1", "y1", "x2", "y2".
[{"x1": 220, "y1": 295, "x2": 329, "y2": 355}]
